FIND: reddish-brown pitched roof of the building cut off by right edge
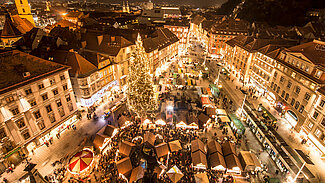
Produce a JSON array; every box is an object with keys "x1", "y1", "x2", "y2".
[{"x1": 286, "y1": 40, "x2": 325, "y2": 67}]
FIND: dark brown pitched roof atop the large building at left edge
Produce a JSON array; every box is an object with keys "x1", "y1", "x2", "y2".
[{"x1": 0, "y1": 50, "x2": 69, "y2": 93}]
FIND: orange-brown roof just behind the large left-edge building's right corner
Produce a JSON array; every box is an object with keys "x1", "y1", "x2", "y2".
[{"x1": 50, "y1": 50, "x2": 98, "y2": 77}]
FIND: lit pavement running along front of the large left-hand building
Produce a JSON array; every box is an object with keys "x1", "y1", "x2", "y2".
[{"x1": 1, "y1": 95, "x2": 121, "y2": 182}]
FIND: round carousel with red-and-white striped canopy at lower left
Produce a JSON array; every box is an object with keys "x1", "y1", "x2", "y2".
[{"x1": 67, "y1": 148, "x2": 94, "y2": 178}]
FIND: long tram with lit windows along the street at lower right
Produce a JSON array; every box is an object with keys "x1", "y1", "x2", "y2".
[{"x1": 243, "y1": 101, "x2": 316, "y2": 182}]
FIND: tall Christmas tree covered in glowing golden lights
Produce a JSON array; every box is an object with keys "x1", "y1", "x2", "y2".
[{"x1": 127, "y1": 35, "x2": 157, "y2": 119}]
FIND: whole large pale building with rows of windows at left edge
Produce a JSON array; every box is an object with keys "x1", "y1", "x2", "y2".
[{"x1": 0, "y1": 51, "x2": 77, "y2": 172}]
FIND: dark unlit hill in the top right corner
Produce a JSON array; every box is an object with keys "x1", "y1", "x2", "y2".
[{"x1": 218, "y1": 0, "x2": 325, "y2": 26}]
